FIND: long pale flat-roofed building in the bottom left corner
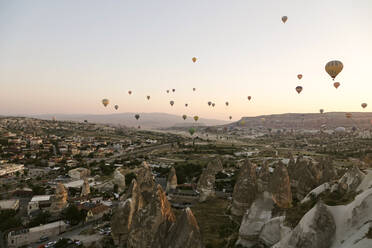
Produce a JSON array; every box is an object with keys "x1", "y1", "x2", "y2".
[{"x1": 8, "y1": 221, "x2": 69, "y2": 248}]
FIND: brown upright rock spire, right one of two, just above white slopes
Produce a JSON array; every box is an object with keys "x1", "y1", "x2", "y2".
[{"x1": 269, "y1": 162, "x2": 292, "y2": 208}]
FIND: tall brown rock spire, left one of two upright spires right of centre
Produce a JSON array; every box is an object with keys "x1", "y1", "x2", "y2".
[{"x1": 231, "y1": 160, "x2": 258, "y2": 216}]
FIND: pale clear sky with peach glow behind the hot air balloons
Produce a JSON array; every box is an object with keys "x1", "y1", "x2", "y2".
[{"x1": 0, "y1": 0, "x2": 372, "y2": 120}]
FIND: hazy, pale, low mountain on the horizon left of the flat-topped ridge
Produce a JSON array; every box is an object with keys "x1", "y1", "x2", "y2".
[{"x1": 30, "y1": 113, "x2": 228, "y2": 129}]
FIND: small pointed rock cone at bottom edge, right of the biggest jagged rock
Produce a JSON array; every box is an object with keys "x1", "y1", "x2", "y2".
[{"x1": 161, "y1": 208, "x2": 204, "y2": 248}]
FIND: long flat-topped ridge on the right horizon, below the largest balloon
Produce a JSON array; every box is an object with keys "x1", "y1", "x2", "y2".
[{"x1": 229, "y1": 112, "x2": 372, "y2": 129}]
